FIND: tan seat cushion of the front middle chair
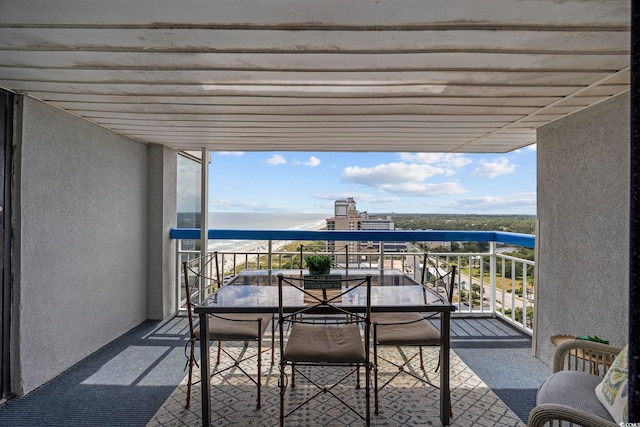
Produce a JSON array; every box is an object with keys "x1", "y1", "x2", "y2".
[{"x1": 284, "y1": 323, "x2": 367, "y2": 363}]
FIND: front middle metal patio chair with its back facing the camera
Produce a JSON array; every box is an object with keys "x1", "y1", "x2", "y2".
[{"x1": 278, "y1": 274, "x2": 373, "y2": 426}]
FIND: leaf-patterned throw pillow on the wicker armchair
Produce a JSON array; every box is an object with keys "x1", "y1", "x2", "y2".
[{"x1": 596, "y1": 345, "x2": 629, "y2": 424}]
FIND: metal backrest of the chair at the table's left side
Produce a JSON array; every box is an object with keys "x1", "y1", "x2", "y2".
[{"x1": 182, "y1": 252, "x2": 221, "y2": 334}]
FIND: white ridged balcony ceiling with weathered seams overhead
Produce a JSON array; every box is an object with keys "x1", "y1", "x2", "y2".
[{"x1": 0, "y1": 0, "x2": 630, "y2": 153}]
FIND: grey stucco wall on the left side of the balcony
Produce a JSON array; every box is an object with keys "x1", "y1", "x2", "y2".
[{"x1": 13, "y1": 97, "x2": 148, "y2": 393}]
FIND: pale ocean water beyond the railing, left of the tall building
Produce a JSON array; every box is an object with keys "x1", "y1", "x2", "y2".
[{"x1": 209, "y1": 212, "x2": 332, "y2": 252}]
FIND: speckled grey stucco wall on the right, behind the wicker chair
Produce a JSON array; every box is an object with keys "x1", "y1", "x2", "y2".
[{"x1": 536, "y1": 94, "x2": 629, "y2": 362}]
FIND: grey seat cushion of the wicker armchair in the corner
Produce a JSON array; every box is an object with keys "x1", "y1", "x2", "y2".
[{"x1": 537, "y1": 371, "x2": 613, "y2": 421}]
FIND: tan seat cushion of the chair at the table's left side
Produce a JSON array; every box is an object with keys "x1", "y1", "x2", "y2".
[{"x1": 193, "y1": 313, "x2": 271, "y2": 341}]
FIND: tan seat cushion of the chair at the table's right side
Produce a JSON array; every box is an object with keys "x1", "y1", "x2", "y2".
[{"x1": 371, "y1": 312, "x2": 440, "y2": 346}]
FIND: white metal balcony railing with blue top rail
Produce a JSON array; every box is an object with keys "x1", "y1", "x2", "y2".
[{"x1": 171, "y1": 229, "x2": 536, "y2": 332}]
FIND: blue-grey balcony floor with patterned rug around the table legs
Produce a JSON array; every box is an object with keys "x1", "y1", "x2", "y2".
[{"x1": 0, "y1": 317, "x2": 550, "y2": 426}]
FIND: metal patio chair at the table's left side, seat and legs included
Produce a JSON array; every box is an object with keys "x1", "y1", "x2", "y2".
[{"x1": 182, "y1": 252, "x2": 275, "y2": 409}]
